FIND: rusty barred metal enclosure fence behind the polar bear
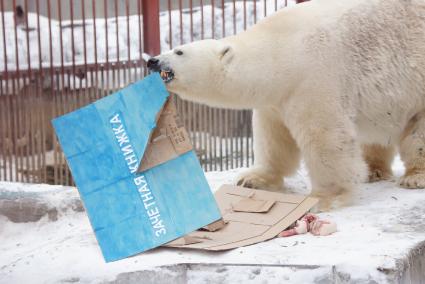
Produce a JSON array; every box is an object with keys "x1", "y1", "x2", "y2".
[{"x1": 0, "y1": 0, "x2": 302, "y2": 185}]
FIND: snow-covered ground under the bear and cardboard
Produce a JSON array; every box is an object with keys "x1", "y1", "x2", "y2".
[{"x1": 0, "y1": 156, "x2": 425, "y2": 283}]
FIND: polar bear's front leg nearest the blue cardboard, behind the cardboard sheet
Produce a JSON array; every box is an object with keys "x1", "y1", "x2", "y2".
[{"x1": 237, "y1": 109, "x2": 300, "y2": 190}]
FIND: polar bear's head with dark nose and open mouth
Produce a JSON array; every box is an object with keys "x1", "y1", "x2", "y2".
[{"x1": 147, "y1": 40, "x2": 252, "y2": 108}]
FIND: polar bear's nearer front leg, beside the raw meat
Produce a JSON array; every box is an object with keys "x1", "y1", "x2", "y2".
[{"x1": 285, "y1": 99, "x2": 367, "y2": 211}]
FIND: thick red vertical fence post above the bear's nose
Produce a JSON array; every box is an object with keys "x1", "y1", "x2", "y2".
[{"x1": 142, "y1": 0, "x2": 161, "y2": 55}]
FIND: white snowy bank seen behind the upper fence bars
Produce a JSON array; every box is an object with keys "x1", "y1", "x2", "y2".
[{"x1": 0, "y1": 0, "x2": 294, "y2": 71}]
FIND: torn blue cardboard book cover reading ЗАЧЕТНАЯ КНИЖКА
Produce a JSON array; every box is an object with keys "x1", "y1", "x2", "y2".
[{"x1": 53, "y1": 74, "x2": 221, "y2": 262}]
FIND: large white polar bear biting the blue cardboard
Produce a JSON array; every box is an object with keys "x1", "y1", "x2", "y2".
[{"x1": 148, "y1": 0, "x2": 425, "y2": 209}]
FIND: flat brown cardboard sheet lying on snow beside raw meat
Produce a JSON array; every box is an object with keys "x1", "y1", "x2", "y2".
[{"x1": 166, "y1": 185, "x2": 318, "y2": 251}]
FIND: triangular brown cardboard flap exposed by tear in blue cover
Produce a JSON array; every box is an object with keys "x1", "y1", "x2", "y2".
[{"x1": 138, "y1": 99, "x2": 193, "y2": 172}]
